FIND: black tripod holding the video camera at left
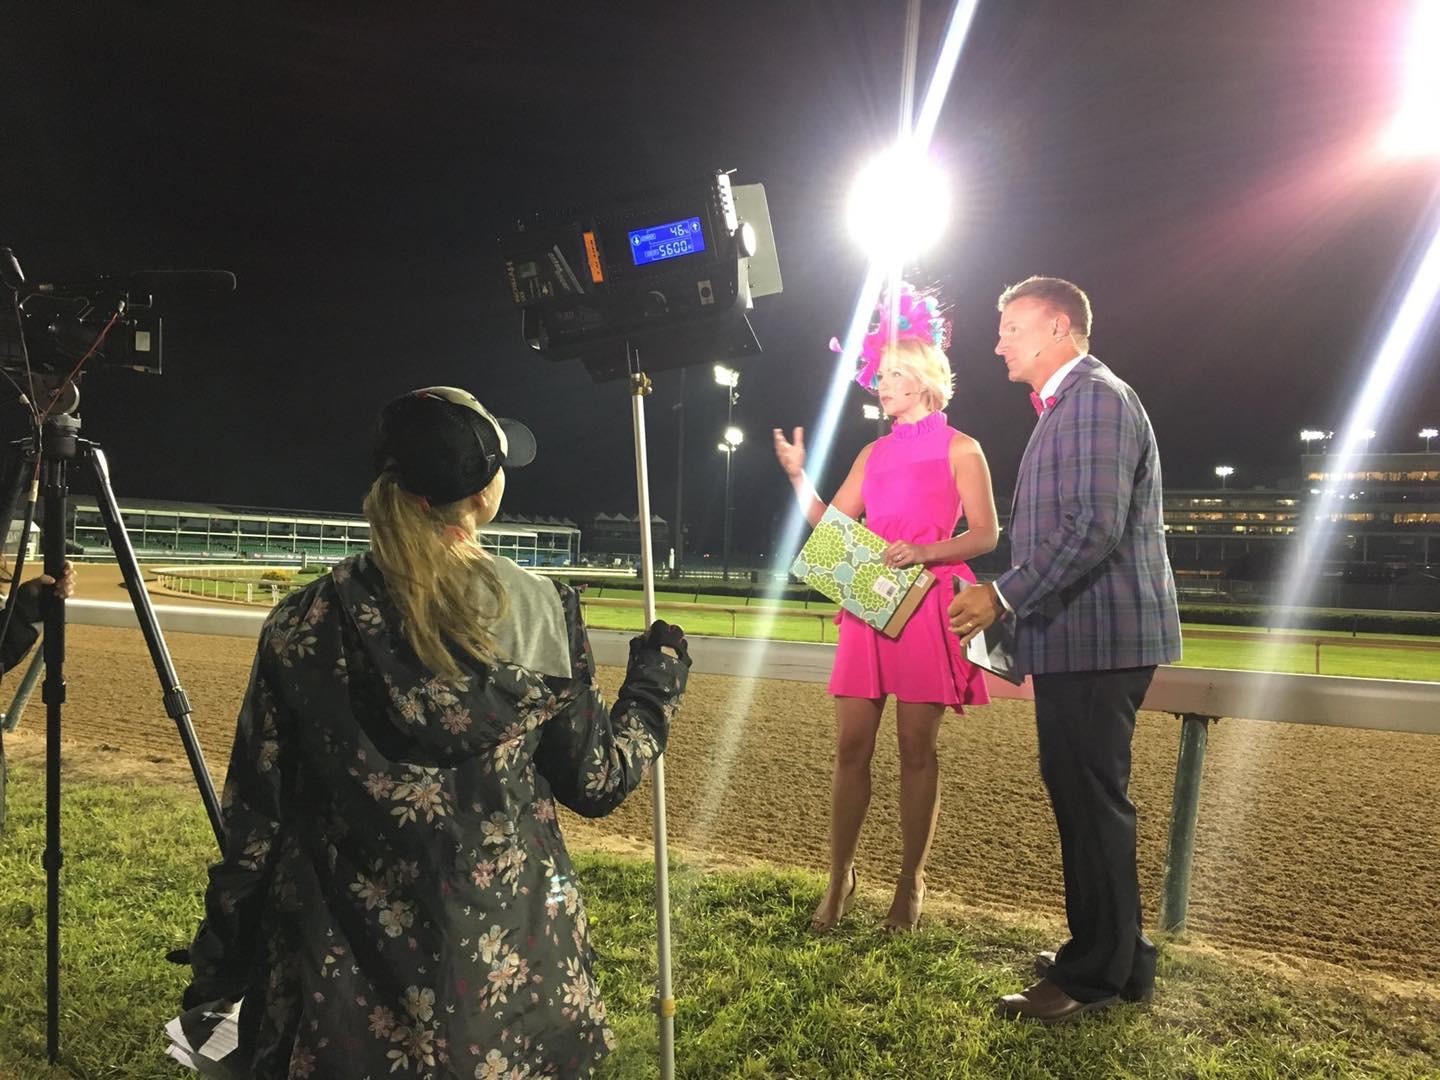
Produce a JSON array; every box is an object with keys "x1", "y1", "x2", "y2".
[{"x1": 0, "y1": 413, "x2": 225, "y2": 1064}]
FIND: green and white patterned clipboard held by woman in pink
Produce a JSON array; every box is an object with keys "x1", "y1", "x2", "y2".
[{"x1": 791, "y1": 507, "x2": 935, "y2": 638}]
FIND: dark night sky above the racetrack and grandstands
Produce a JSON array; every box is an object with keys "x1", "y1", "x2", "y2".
[{"x1": 0, "y1": 0, "x2": 1440, "y2": 552}]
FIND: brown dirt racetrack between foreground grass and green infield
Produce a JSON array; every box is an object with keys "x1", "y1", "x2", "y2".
[{"x1": 6, "y1": 567, "x2": 1440, "y2": 982}]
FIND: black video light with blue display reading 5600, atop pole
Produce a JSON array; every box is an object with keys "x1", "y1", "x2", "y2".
[{"x1": 500, "y1": 171, "x2": 780, "y2": 380}]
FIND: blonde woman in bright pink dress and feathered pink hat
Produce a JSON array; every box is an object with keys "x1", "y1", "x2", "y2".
[{"x1": 775, "y1": 287, "x2": 998, "y2": 933}]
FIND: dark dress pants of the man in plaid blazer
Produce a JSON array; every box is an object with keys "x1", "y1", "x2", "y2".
[{"x1": 1034, "y1": 667, "x2": 1155, "y2": 1002}]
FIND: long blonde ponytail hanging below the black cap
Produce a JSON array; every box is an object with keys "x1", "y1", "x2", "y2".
[{"x1": 364, "y1": 471, "x2": 507, "y2": 680}]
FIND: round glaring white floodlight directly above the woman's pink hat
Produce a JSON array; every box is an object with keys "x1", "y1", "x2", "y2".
[{"x1": 847, "y1": 138, "x2": 950, "y2": 266}]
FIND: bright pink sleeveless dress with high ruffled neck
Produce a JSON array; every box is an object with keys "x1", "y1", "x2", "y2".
[{"x1": 829, "y1": 412, "x2": 989, "y2": 713}]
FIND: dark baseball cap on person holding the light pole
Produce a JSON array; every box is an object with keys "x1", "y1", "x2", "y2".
[{"x1": 374, "y1": 386, "x2": 536, "y2": 504}]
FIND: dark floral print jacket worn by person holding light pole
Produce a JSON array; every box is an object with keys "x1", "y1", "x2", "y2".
[{"x1": 186, "y1": 554, "x2": 690, "y2": 1080}]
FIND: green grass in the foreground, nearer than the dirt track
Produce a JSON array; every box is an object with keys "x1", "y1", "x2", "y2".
[{"x1": 0, "y1": 763, "x2": 1440, "y2": 1080}]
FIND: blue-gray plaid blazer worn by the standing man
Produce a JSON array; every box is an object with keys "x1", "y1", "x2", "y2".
[{"x1": 995, "y1": 356, "x2": 1181, "y2": 674}]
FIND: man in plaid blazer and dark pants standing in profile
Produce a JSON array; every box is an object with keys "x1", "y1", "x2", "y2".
[{"x1": 950, "y1": 278, "x2": 1181, "y2": 1022}]
